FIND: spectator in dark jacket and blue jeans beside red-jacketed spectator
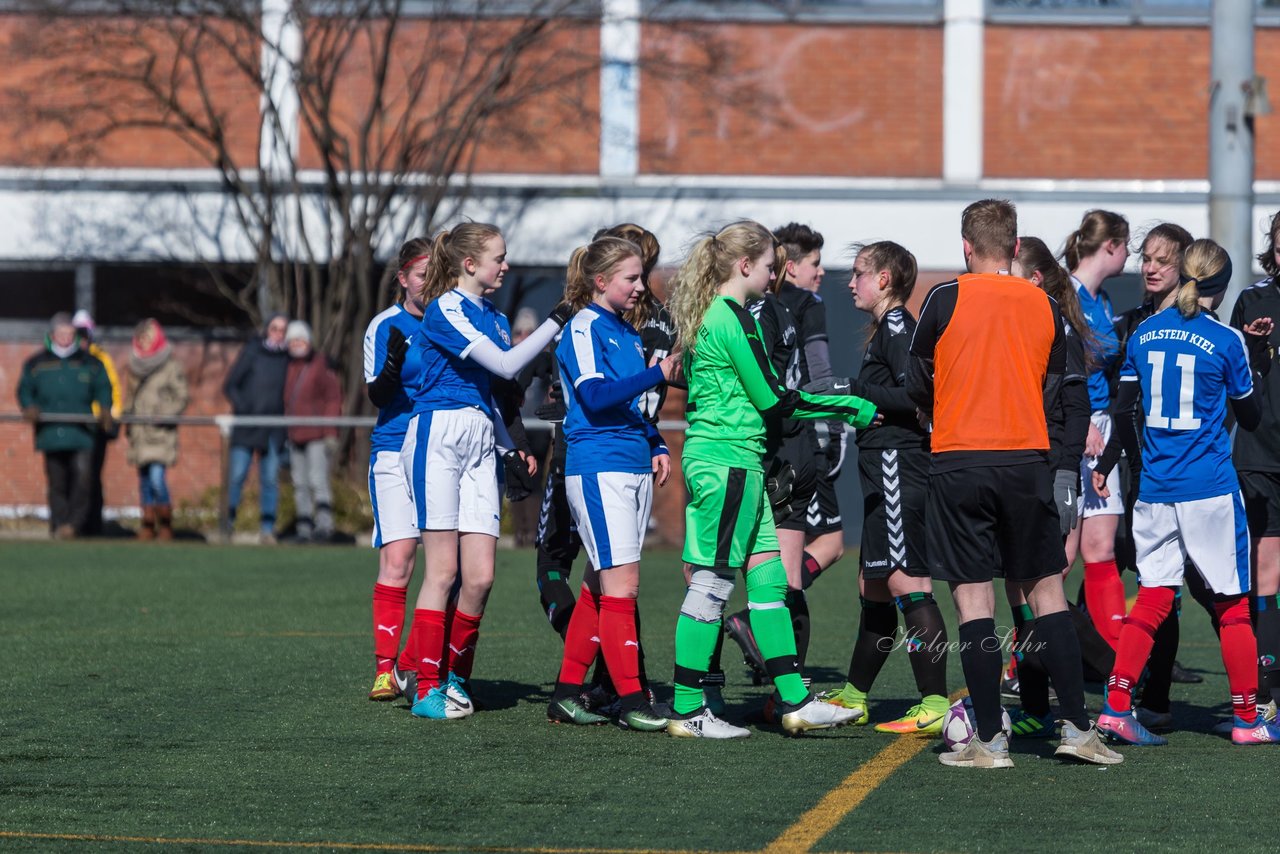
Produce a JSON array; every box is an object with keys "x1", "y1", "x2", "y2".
[{"x1": 223, "y1": 314, "x2": 289, "y2": 543}]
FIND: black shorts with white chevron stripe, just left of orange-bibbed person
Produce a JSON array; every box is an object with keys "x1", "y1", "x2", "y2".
[{"x1": 858, "y1": 448, "x2": 929, "y2": 579}]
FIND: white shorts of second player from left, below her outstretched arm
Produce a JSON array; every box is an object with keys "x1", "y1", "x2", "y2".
[{"x1": 401, "y1": 407, "x2": 502, "y2": 536}]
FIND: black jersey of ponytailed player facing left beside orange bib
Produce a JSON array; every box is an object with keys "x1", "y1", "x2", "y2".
[{"x1": 851, "y1": 306, "x2": 929, "y2": 451}]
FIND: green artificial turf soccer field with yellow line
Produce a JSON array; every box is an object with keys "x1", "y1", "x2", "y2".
[{"x1": 0, "y1": 543, "x2": 1280, "y2": 853}]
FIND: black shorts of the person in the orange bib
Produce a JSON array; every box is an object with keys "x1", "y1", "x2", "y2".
[{"x1": 925, "y1": 462, "x2": 1066, "y2": 584}]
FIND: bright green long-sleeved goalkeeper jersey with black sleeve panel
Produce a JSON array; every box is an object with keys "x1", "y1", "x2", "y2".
[{"x1": 682, "y1": 296, "x2": 876, "y2": 471}]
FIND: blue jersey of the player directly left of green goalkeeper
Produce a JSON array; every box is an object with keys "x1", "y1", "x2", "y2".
[{"x1": 556, "y1": 305, "x2": 667, "y2": 475}]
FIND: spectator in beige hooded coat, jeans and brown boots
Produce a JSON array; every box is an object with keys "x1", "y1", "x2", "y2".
[{"x1": 124, "y1": 318, "x2": 189, "y2": 540}]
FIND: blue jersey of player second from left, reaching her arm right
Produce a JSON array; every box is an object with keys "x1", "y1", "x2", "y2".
[{"x1": 406, "y1": 289, "x2": 511, "y2": 415}]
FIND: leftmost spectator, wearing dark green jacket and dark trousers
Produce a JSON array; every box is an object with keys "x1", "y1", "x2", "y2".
[{"x1": 18, "y1": 312, "x2": 115, "y2": 539}]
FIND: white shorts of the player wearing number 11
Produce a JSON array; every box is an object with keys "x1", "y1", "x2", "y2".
[{"x1": 1133, "y1": 492, "x2": 1249, "y2": 595}]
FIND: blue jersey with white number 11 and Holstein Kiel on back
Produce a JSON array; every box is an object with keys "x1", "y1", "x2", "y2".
[{"x1": 1120, "y1": 306, "x2": 1253, "y2": 503}]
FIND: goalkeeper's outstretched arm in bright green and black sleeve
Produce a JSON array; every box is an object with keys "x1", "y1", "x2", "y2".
[{"x1": 724, "y1": 309, "x2": 876, "y2": 428}]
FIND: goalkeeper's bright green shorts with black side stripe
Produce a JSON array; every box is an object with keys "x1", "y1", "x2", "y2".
[{"x1": 681, "y1": 457, "x2": 778, "y2": 570}]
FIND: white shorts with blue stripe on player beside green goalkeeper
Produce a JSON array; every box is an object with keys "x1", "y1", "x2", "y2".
[{"x1": 564, "y1": 471, "x2": 653, "y2": 570}]
